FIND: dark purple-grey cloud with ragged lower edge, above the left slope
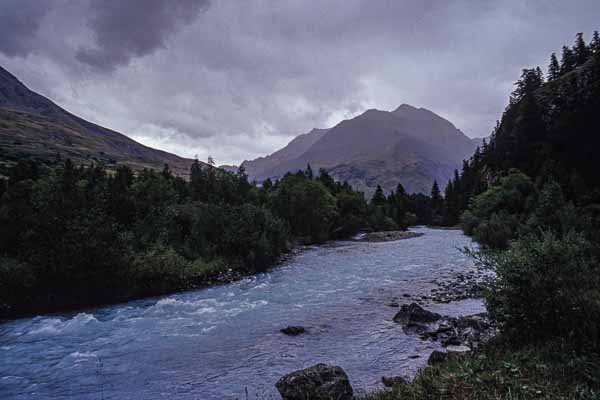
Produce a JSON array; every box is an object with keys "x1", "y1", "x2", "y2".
[{"x1": 76, "y1": 0, "x2": 208, "y2": 70}]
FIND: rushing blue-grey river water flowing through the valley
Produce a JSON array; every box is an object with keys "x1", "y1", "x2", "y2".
[{"x1": 0, "y1": 228, "x2": 483, "y2": 400}]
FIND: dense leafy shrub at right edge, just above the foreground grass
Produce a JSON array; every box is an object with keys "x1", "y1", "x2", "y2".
[{"x1": 480, "y1": 232, "x2": 600, "y2": 349}]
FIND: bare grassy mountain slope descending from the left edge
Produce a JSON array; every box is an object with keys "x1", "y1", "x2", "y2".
[{"x1": 0, "y1": 67, "x2": 193, "y2": 175}]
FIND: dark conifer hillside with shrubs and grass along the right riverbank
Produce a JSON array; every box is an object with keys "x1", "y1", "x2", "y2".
[{"x1": 368, "y1": 33, "x2": 600, "y2": 400}]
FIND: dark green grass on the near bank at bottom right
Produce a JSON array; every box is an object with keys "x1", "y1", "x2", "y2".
[{"x1": 361, "y1": 342, "x2": 600, "y2": 400}]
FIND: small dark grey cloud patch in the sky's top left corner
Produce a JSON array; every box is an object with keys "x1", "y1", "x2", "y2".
[{"x1": 0, "y1": 0, "x2": 51, "y2": 57}]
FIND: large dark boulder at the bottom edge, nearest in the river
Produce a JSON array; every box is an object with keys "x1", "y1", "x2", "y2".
[{"x1": 275, "y1": 364, "x2": 353, "y2": 400}]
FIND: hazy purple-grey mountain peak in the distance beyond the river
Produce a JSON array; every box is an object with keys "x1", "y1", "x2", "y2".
[{"x1": 242, "y1": 104, "x2": 476, "y2": 195}]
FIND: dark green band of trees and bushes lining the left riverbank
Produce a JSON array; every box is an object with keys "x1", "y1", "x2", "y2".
[{"x1": 0, "y1": 157, "x2": 418, "y2": 317}]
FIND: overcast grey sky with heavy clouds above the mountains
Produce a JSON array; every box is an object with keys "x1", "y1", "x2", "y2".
[{"x1": 0, "y1": 0, "x2": 600, "y2": 164}]
